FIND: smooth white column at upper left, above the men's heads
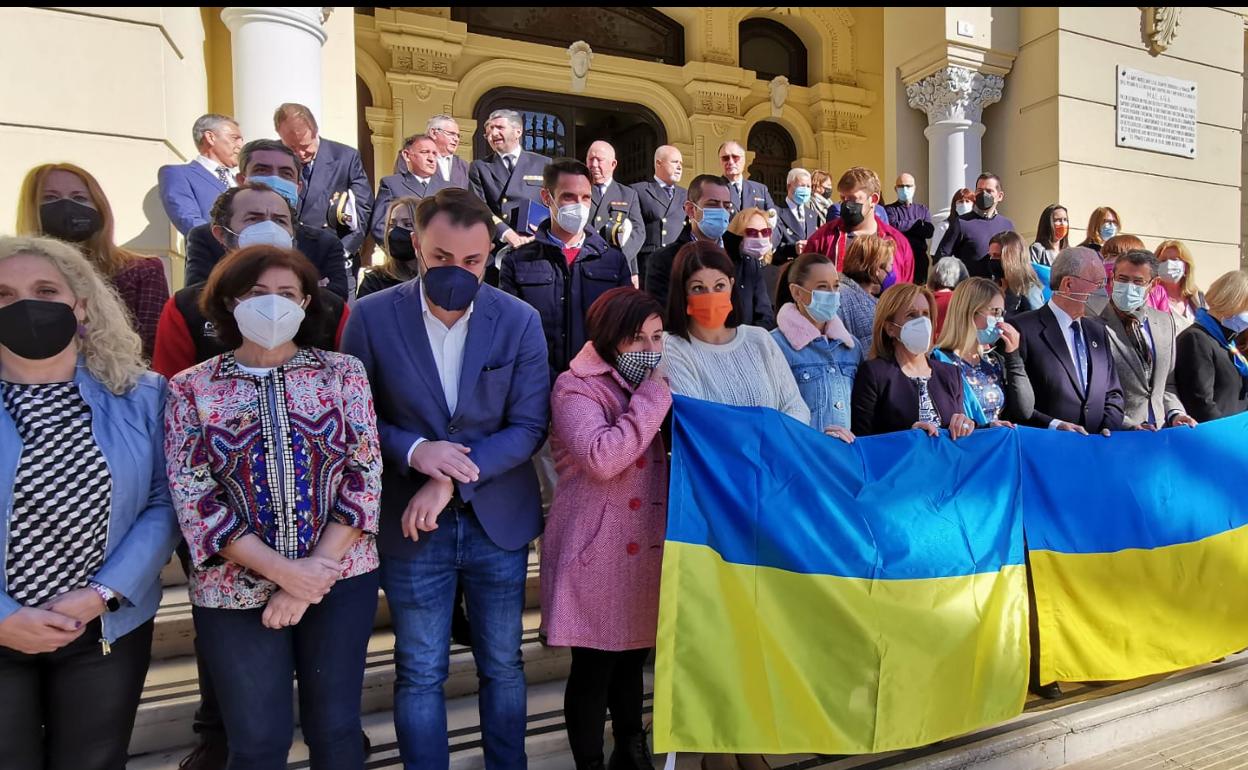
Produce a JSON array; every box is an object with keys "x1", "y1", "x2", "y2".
[{"x1": 221, "y1": 6, "x2": 333, "y2": 141}]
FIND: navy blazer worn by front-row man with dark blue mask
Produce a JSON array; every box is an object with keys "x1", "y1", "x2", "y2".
[{"x1": 342, "y1": 280, "x2": 550, "y2": 558}]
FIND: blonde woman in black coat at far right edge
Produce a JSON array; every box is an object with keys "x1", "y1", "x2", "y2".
[{"x1": 1174, "y1": 270, "x2": 1248, "y2": 422}]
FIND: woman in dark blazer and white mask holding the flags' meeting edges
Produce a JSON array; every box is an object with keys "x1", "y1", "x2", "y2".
[{"x1": 851, "y1": 283, "x2": 975, "y2": 439}]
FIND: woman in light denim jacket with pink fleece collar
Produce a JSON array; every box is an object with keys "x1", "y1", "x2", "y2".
[{"x1": 771, "y1": 253, "x2": 862, "y2": 443}]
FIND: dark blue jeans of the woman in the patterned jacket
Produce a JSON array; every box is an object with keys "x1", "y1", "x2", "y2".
[{"x1": 192, "y1": 570, "x2": 379, "y2": 770}]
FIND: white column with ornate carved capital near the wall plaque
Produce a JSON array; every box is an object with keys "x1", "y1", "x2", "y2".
[{"x1": 906, "y1": 66, "x2": 1005, "y2": 227}]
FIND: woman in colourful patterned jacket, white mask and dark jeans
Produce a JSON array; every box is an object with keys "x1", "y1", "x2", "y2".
[{"x1": 165, "y1": 246, "x2": 381, "y2": 770}]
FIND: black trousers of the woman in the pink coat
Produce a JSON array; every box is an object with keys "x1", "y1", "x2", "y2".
[{"x1": 563, "y1": 646, "x2": 650, "y2": 768}]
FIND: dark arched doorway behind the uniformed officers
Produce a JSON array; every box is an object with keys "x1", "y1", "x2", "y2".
[{"x1": 473, "y1": 87, "x2": 668, "y2": 185}]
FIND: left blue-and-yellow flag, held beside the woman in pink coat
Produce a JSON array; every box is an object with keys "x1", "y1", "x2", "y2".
[{"x1": 654, "y1": 397, "x2": 1028, "y2": 754}]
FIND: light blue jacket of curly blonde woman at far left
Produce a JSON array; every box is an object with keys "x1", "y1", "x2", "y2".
[{"x1": 0, "y1": 359, "x2": 180, "y2": 644}]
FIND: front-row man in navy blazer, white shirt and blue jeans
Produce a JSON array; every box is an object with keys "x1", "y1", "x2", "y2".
[{"x1": 342, "y1": 188, "x2": 550, "y2": 770}]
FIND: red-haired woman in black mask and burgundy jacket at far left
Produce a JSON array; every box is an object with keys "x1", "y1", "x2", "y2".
[{"x1": 17, "y1": 163, "x2": 168, "y2": 359}]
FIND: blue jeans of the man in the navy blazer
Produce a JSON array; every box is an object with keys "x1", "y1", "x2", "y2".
[{"x1": 379, "y1": 510, "x2": 528, "y2": 770}]
